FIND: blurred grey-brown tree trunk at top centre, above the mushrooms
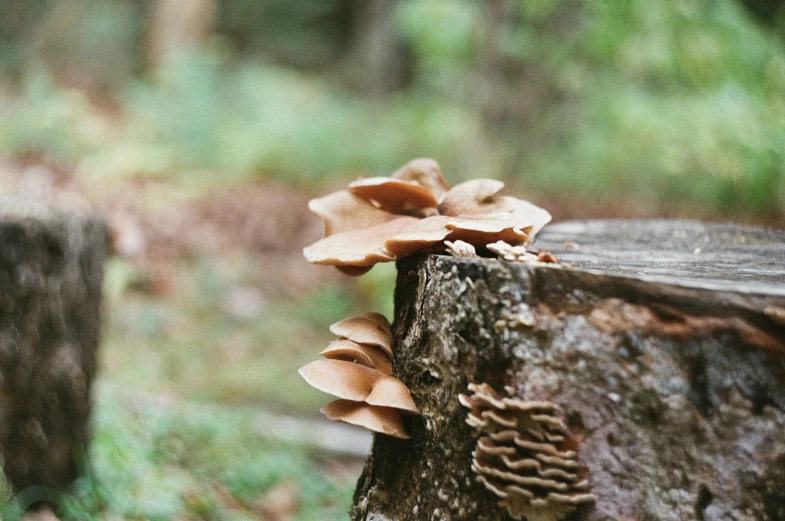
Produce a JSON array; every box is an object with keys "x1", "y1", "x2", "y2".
[{"x1": 351, "y1": 0, "x2": 407, "y2": 96}]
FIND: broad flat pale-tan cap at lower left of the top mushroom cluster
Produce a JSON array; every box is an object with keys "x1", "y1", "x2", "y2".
[{"x1": 303, "y1": 215, "x2": 420, "y2": 267}]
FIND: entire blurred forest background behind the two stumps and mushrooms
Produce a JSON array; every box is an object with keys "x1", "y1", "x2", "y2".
[{"x1": 0, "y1": 0, "x2": 785, "y2": 521}]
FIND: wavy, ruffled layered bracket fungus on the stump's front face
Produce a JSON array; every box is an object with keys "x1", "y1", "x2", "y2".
[{"x1": 458, "y1": 384, "x2": 594, "y2": 521}]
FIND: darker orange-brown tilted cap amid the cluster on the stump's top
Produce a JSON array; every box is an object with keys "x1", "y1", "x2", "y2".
[{"x1": 349, "y1": 177, "x2": 439, "y2": 214}]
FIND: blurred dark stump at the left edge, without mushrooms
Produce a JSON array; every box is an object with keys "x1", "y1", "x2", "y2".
[{"x1": 0, "y1": 198, "x2": 106, "y2": 490}]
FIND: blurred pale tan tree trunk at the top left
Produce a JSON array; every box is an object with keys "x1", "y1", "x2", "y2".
[{"x1": 147, "y1": 0, "x2": 218, "y2": 68}]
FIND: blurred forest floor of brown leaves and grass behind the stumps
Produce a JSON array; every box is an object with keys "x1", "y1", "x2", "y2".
[{"x1": 0, "y1": 160, "x2": 776, "y2": 521}]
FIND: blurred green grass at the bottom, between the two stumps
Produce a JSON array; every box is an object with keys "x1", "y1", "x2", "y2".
[{"x1": 0, "y1": 383, "x2": 354, "y2": 521}]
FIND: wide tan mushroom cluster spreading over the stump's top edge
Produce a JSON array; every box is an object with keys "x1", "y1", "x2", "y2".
[{"x1": 303, "y1": 159, "x2": 551, "y2": 275}]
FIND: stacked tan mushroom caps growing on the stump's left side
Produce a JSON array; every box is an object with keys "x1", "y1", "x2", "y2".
[{"x1": 299, "y1": 312, "x2": 420, "y2": 439}]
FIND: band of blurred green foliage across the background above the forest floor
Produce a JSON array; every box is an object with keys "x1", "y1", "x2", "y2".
[{"x1": 0, "y1": 0, "x2": 785, "y2": 213}]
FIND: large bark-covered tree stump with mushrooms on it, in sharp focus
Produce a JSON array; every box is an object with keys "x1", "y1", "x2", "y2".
[{"x1": 351, "y1": 221, "x2": 785, "y2": 521}]
